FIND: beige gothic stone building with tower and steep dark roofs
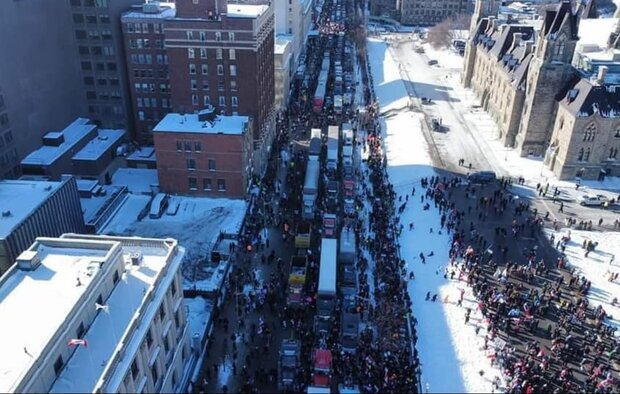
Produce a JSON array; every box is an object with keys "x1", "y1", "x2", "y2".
[{"x1": 462, "y1": 0, "x2": 618, "y2": 179}]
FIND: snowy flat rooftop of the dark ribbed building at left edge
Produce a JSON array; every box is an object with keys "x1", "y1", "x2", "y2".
[{"x1": 0, "y1": 180, "x2": 62, "y2": 240}]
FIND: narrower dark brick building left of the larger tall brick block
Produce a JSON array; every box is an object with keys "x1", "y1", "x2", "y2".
[{"x1": 121, "y1": 2, "x2": 176, "y2": 145}]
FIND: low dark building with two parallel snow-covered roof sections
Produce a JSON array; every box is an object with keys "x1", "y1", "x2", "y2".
[{"x1": 21, "y1": 118, "x2": 126, "y2": 181}]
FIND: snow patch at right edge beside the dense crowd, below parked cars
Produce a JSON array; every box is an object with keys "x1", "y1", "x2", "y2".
[{"x1": 547, "y1": 229, "x2": 620, "y2": 336}]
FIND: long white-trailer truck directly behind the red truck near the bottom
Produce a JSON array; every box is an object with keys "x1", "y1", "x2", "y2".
[{"x1": 317, "y1": 238, "x2": 338, "y2": 320}]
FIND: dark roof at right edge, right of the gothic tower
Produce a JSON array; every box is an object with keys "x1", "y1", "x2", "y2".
[{"x1": 560, "y1": 78, "x2": 620, "y2": 118}]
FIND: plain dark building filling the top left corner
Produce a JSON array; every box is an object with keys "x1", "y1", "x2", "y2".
[{"x1": 0, "y1": 0, "x2": 86, "y2": 178}]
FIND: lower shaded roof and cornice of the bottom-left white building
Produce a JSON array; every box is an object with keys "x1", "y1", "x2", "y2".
[{"x1": 50, "y1": 234, "x2": 184, "y2": 393}]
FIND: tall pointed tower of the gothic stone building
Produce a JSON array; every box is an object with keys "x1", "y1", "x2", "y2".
[{"x1": 516, "y1": 1, "x2": 579, "y2": 156}]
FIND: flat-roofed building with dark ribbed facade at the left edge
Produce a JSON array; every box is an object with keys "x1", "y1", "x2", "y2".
[{"x1": 0, "y1": 177, "x2": 84, "y2": 274}]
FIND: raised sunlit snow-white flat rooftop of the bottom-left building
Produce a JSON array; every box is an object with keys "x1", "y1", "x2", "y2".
[{"x1": 0, "y1": 238, "x2": 114, "y2": 393}]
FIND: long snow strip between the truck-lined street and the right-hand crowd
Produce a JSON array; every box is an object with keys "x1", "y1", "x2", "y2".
[{"x1": 368, "y1": 40, "x2": 501, "y2": 392}]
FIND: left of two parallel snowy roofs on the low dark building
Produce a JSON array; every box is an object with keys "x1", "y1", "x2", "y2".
[{"x1": 22, "y1": 118, "x2": 97, "y2": 166}]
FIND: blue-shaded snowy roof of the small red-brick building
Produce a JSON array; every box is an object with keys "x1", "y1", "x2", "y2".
[{"x1": 153, "y1": 113, "x2": 249, "y2": 134}]
